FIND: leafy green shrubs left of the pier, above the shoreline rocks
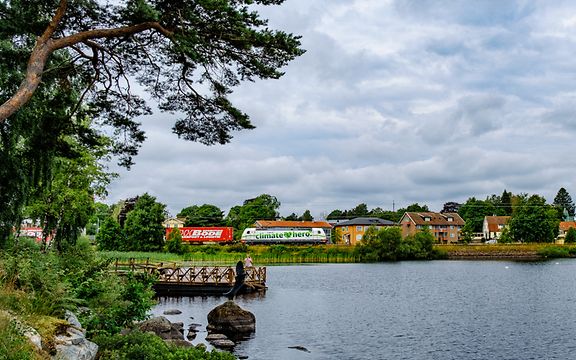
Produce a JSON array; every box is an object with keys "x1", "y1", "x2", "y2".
[{"x1": 0, "y1": 238, "x2": 155, "y2": 334}]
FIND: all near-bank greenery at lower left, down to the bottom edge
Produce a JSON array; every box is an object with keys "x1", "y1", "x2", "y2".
[{"x1": 0, "y1": 239, "x2": 234, "y2": 359}]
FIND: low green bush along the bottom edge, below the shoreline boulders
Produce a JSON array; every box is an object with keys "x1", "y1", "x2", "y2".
[{"x1": 94, "y1": 331, "x2": 236, "y2": 360}]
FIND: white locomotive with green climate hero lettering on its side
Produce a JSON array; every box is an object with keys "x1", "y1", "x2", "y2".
[{"x1": 241, "y1": 228, "x2": 328, "y2": 245}]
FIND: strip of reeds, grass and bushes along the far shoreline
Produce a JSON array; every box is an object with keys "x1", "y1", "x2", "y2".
[{"x1": 100, "y1": 242, "x2": 576, "y2": 266}]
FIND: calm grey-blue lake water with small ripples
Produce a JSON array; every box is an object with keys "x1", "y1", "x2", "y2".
[{"x1": 153, "y1": 260, "x2": 576, "y2": 360}]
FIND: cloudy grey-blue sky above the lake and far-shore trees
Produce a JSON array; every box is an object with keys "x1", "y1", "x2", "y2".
[{"x1": 106, "y1": 0, "x2": 576, "y2": 219}]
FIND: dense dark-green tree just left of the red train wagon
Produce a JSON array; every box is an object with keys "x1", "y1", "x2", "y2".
[{"x1": 123, "y1": 193, "x2": 166, "y2": 251}]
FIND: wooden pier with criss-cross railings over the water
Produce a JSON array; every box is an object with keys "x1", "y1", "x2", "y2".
[{"x1": 114, "y1": 259, "x2": 266, "y2": 295}]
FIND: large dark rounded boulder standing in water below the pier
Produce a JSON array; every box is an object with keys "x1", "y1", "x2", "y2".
[{"x1": 206, "y1": 300, "x2": 256, "y2": 339}]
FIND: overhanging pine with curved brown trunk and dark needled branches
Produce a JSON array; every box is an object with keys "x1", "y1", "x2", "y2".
[{"x1": 0, "y1": 0, "x2": 304, "y2": 151}]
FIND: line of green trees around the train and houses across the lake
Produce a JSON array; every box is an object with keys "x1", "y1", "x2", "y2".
[{"x1": 87, "y1": 188, "x2": 576, "y2": 250}]
